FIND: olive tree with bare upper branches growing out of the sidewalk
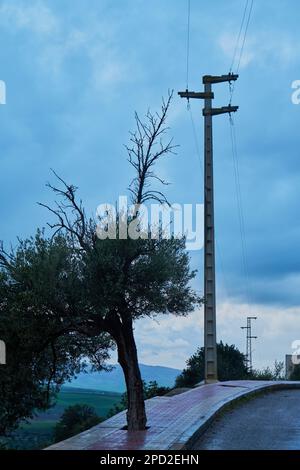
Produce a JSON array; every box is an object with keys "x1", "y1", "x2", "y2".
[{"x1": 2, "y1": 94, "x2": 200, "y2": 430}]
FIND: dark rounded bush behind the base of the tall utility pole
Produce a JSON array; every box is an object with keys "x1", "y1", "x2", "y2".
[{"x1": 175, "y1": 342, "x2": 249, "y2": 387}]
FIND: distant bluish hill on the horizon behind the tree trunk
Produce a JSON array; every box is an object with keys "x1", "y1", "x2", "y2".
[{"x1": 66, "y1": 364, "x2": 181, "y2": 393}]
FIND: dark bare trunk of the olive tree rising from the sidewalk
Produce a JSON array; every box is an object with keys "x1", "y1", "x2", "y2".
[{"x1": 115, "y1": 321, "x2": 147, "y2": 431}]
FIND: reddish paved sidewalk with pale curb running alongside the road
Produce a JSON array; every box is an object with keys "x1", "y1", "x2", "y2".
[{"x1": 46, "y1": 380, "x2": 300, "y2": 450}]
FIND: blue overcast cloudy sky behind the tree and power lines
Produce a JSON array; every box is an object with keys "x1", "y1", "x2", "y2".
[{"x1": 0, "y1": 0, "x2": 300, "y2": 367}]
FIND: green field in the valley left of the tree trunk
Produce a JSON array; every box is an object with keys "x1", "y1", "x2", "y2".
[{"x1": 7, "y1": 387, "x2": 121, "y2": 449}]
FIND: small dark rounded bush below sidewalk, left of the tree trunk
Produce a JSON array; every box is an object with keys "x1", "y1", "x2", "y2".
[{"x1": 54, "y1": 404, "x2": 103, "y2": 442}]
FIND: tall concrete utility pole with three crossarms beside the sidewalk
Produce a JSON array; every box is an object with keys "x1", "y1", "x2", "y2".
[{"x1": 178, "y1": 73, "x2": 238, "y2": 383}]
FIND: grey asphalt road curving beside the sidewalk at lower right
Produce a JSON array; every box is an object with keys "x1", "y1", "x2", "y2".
[{"x1": 193, "y1": 390, "x2": 300, "y2": 450}]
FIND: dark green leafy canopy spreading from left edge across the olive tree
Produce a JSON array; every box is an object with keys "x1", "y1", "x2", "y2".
[{"x1": 0, "y1": 224, "x2": 197, "y2": 434}]
